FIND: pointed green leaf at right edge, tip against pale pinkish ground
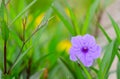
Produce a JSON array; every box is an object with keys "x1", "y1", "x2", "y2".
[{"x1": 108, "y1": 14, "x2": 120, "y2": 43}]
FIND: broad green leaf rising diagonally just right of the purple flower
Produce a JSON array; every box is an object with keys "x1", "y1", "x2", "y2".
[{"x1": 98, "y1": 41, "x2": 115, "y2": 79}]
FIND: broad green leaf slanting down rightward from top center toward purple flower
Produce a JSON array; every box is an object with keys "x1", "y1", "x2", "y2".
[{"x1": 52, "y1": 2, "x2": 75, "y2": 35}]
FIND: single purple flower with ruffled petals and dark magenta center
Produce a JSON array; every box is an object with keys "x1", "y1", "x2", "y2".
[{"x1": 70, "y1": 34, "x2": 101, "y2": 67}]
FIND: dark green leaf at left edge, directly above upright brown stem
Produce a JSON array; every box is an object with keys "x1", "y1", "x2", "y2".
[{"x1": 0, "y1": 21, "x2": 9, "y2": 41}]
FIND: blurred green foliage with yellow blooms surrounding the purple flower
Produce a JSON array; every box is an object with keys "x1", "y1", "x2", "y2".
[{"x1": 0, "y1": 0, "x2": 120, "y2": 79}]
